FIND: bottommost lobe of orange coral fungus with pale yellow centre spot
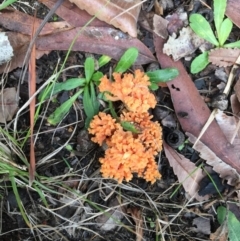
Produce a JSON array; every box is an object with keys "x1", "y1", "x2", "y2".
[{"x1": 100, "y1": 129, "x2": 161, "y2": 183}]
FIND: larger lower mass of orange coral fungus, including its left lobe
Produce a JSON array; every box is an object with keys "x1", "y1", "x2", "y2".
[{"x1": 90, "y1": 112, "x2": 162, "y2": 183}]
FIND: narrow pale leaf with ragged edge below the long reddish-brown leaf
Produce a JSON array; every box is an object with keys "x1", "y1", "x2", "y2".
[{"x1": 186, "y1": 132, "x2": 240, "y2": 186}]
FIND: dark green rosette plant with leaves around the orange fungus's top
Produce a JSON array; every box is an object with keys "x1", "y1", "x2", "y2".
[{"x1": 42, "y1": 48, "x2": 178, "y2": 128}]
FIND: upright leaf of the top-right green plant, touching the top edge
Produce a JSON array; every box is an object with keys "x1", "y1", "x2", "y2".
[{"x1": 213, "y1": 0, "x2": 227, "y2": 39}]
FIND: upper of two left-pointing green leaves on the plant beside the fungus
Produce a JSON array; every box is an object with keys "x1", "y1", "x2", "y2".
[{"x1": 38, "y1": 78, "x2": 86, "y2": 100}]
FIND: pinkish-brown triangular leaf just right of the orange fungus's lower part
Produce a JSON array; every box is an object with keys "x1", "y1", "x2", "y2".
[{"x1": 163, "y1": 143, "x2": 208, "y2": 201}]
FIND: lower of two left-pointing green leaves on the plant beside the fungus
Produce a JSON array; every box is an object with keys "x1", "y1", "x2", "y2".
[{"x1": 47, "y1": 89, "x2": 83, "y2": 125}]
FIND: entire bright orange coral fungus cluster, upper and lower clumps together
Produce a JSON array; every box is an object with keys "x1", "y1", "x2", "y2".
[{"x1": 89, "y1": 70, "x2": 162, "y2": 183}]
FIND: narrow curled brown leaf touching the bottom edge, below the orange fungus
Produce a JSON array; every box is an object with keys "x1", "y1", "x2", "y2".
[{"x1": 127, "y1": 207, "x2": 143, "y2": 241}]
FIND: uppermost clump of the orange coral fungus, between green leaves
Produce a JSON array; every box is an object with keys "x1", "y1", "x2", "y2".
[{"x1": 99, "y1": 70, "x2": 156, "y2": 112}]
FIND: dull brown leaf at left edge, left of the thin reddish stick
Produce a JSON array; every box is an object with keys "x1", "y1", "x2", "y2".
[{"x1": 0, "y1": 87, "x2": 18, "y2": 123}]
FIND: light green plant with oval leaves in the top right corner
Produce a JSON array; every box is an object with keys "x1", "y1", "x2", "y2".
[{"x1": 189, "y1": 0, "x2": 240, "y2": 74}]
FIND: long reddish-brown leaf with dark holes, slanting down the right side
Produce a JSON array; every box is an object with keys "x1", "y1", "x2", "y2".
[{"x1": 154, "y1": 35, "x2": 240, "y2": 177}]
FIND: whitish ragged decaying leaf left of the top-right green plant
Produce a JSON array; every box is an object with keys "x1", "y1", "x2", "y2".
[{"x1": 163, "y1": 27, "x2": 208, "y2": 61}]
